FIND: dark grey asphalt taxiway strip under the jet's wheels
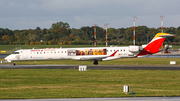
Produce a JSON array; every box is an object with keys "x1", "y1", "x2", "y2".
[{"x1": 0, "y1": 64, "x2": 180, "y2": 70}]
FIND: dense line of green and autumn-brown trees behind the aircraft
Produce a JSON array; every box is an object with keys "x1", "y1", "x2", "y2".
[{"x1": 0, "y1": 22, "x2": 180, "y2": 45}]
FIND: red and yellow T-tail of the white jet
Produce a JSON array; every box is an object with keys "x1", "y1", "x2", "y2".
[{"x1": 137, "y1": 33, "x2": 175, "y2": 56}]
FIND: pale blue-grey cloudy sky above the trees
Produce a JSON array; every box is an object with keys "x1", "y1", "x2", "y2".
[{"x1": 0, "y1": 0, "x2": 180, "y2": 30}]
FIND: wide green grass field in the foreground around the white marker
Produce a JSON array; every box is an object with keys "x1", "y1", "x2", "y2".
[{"x1": 0, "y1": 69, "x2": 180, "y2": 99}]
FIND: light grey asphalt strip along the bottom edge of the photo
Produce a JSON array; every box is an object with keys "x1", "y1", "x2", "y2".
[{"x1": 0, "y1": 97, "x2": 180, "y2": 101}]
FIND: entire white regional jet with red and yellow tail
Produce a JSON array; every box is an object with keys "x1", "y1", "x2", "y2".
[{"x1": 5, "y1": 33, "x2": 174, "y2": 65}]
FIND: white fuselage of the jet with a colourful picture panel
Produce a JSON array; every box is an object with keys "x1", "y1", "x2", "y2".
[{"x1": 5, "y1": 46, "x2": 140, "y2": 62}]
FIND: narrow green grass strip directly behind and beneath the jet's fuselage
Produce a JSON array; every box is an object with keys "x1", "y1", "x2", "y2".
[{"x1": 0, "y1": 58, "x2": 180, "y2": 65}]
